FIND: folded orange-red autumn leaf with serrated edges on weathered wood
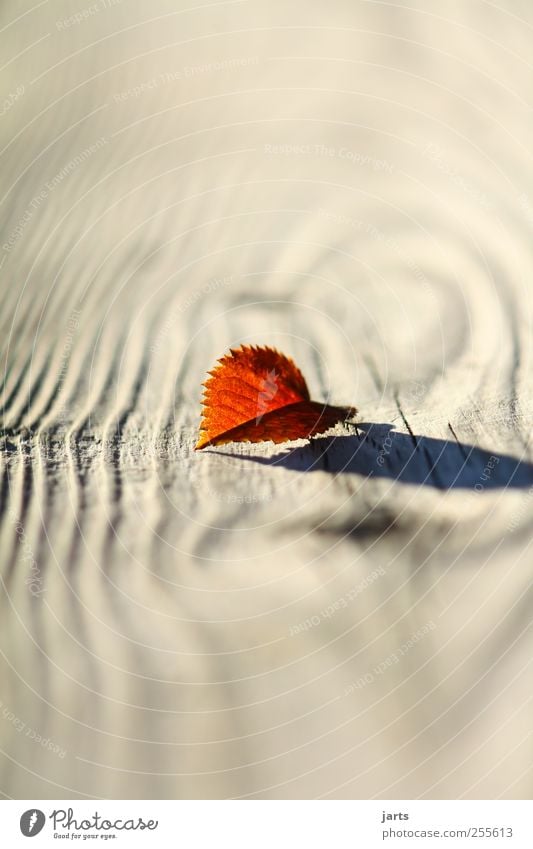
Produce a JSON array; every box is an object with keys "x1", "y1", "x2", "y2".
[{"x1": 196, "y1": 345, "x2": 356, "y2": 450}]
